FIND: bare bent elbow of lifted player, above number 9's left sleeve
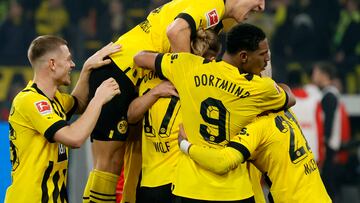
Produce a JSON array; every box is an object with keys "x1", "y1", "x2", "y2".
[{"x1": 166, "y1": 17, "x2": 196, "y2": 52}]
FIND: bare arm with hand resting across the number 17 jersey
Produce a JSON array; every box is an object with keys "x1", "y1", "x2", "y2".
[{"x1": 127, "y1": 81, "x2": 179, "y2": 124}]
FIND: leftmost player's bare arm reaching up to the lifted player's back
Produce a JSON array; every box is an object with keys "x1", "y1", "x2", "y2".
[{"x1": 71, "y1": 42, "x2": 121, "y2": 113}]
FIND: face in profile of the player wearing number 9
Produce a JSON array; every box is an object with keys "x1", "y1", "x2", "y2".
[{"x1": 243, "y1": 39, "x2": 270, "y2": 75}]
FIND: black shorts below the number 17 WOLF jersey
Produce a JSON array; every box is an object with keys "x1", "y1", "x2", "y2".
[{"x1": 136, "y1": 184, "x2": 175, "y2": 203}]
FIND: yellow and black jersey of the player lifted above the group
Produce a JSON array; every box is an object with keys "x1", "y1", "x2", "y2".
[{"x1": 110, "y1": 0, "x2": 225, "y2": 84}]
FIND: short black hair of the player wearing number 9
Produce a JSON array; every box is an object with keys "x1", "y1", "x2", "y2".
[{"x1": 226, "y1": 23, "x2": 266, "y2": 54}]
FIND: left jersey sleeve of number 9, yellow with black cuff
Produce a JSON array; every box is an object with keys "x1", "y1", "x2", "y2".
[{"x1": 155, "y1": 53, "x2": 204, "y2": 87}]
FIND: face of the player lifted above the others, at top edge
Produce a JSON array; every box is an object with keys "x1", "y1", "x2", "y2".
[{"x1": 231, "y1": 0, "x2": 265, "y2": 23}]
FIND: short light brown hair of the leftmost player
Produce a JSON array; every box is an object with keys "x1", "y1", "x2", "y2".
[{"x1": 28, "y1": 35, "x2": 67, "y2": 64}]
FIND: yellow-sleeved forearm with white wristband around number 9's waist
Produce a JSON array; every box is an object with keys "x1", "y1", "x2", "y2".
[{"x1": 179, "y1": 125, "x2": 245, "y2": 175}]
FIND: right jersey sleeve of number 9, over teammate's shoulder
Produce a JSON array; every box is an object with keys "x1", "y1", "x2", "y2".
[{"x1": 257, "y1": 78, "x2": 288, "y2": 111}]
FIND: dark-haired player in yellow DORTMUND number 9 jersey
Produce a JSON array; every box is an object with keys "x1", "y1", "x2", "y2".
[{"x1": 134, "y1": 24, "x2": 295, "y2": 202}]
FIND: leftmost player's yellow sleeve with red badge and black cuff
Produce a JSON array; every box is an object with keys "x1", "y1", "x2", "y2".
[{"x1": 18, "y1": 95, "x2": 67, "y2": 142}]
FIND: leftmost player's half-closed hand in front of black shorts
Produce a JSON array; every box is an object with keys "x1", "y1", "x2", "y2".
[{"x1": 94, "y1": 78, "x2": 120, "y2": 105}]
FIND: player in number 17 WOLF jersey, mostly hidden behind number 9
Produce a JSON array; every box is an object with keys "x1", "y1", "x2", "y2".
[{"x1": 128, "y1": 29, "x2": 220, "y2": 203}]
